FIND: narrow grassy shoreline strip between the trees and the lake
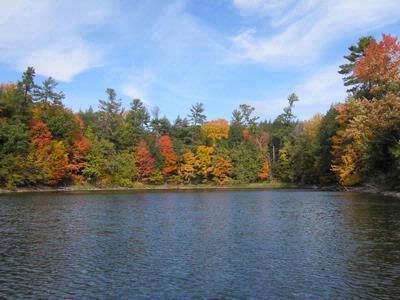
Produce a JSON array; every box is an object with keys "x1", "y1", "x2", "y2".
[{"x1": 0, "y1": 182, "x2": 400, "y2": 199}]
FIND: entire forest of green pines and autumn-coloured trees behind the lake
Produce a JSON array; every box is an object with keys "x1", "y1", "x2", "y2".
[{"x1": 0, "y1": 35, "x2": 400, "y2": 190}]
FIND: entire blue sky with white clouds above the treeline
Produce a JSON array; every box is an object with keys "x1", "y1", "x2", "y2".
[{"x1": 0, "y1": 0, "x2": 400, "y2": 119}]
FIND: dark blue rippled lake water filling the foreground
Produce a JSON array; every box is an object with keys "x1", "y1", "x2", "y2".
[{"x1": 0, "y1": 191, "x2": 400, "y2": 299}]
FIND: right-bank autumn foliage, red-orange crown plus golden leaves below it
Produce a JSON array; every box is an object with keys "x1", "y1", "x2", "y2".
[{"x1": 332, "y1": 35, "x2": 400, "y2": 185}]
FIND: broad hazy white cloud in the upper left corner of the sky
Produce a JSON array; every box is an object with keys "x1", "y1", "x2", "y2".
[{"x1": 0, "y1": 0, "x2": 112, "y2": 81}]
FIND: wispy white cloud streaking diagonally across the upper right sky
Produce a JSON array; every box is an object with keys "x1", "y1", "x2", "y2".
[{"x1": 233, "y1": 0, "x2": 400, "y2": 65}]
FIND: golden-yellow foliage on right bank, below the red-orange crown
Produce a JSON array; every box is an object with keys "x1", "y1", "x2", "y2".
[{"x1": 332, "y1": 95, "x2": 400, "y2": 185}]
